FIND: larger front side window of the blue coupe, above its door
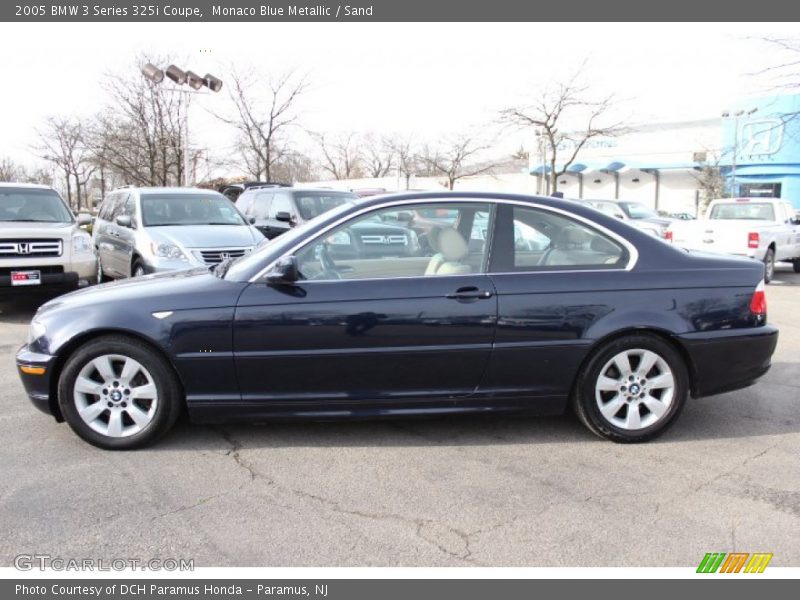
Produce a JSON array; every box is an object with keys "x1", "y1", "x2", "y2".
[{"x1": 297, "y1": 203, "x2": 492, "y2": 281}]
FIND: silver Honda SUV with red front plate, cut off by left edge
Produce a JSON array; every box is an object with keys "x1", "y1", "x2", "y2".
[{"x1": 0, "y1": 183, "x2": 97, "y2": 293}]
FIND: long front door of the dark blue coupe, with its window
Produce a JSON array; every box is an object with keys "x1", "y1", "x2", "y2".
[{"x1": 234, "y1": 203, "x2": 497, "y2": 406}]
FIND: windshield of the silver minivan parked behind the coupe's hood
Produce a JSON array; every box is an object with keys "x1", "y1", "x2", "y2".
[{"x1": 142, "y1": 193, "x2": 246, "y2": 227}]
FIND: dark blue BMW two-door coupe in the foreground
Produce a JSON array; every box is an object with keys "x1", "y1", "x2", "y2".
[{"x1": 17, "y1": 192, "x2": 778, "y2": 449}]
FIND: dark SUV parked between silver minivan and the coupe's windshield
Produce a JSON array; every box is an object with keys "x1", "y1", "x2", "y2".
[{"x1": 236, "y1": 186, "x2": 358, "y2": 239}]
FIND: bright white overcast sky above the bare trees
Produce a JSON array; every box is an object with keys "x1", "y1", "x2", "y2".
[{"x1": 0, "y1": 23, "x2": 800, "y2": 170}]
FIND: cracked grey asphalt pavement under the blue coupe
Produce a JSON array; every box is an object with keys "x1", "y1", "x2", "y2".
[{"x1": 0, "y1": 266, "x2": 800, "y2": 566}]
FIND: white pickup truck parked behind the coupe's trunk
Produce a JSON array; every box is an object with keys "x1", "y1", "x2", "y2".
[{"x1": 665, "y1": 198, "x2": 800, "y2": 283}]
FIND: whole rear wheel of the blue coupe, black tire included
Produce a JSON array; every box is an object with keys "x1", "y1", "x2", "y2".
[{"x1": 572, "y1": 334, "x2": 689, "y2": 443}]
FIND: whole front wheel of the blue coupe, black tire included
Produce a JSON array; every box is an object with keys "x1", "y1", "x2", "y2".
[{"x1": 58, "y1": 335, "x2": 183, "y2": 450}]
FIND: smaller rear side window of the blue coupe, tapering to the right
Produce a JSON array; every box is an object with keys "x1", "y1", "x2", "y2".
[{"x1": 493, "y1": 206, "x2": 628, "y2": 272}]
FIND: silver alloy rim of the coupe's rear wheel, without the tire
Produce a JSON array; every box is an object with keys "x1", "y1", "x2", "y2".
[{"x1": 595, "y1": 349, "x2": 675, "y2": 431}]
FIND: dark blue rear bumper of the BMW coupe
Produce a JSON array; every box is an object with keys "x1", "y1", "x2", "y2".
[{"x1": 678, "y1": 325, "x2": 778, "y2": 398}]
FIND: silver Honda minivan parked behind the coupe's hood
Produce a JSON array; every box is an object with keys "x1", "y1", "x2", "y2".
[{"x1": 92, "y1": 187, "x2": 266, "y2": 281}]
